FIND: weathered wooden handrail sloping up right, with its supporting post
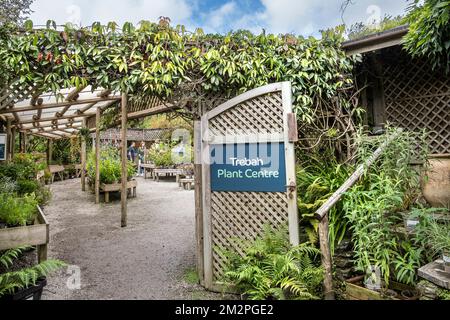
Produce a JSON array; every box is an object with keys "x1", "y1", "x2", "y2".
[{"x1": 315, "y1": 129, "x2": 402, "y2": 300}]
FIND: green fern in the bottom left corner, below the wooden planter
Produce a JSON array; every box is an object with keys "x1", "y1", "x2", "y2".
[{"x1": 0, "y1": 247, "x2": 66, "y2": 300}]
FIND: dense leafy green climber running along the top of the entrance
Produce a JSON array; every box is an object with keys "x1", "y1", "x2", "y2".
[{"x1": 0, "y1": 20, "x2": 353, "y2": 120}]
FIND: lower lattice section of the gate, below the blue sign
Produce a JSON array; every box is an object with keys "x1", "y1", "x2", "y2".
[{"x1": 211, "y1": 192, "x2": 288, "y2": 280}]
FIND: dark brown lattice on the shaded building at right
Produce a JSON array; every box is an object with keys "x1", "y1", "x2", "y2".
[{"x1": 383, "y1": 49, "x2": 450, "y2": 154}]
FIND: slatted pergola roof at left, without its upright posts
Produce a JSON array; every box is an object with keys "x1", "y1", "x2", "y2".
[{"x1": 0, "y1": 86, "x2": 176, "y2": 140}]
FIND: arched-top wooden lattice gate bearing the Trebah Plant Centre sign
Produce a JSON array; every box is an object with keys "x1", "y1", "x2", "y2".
[{"x1": 201, "y1": 82, "x2": 299, "y2": 290}]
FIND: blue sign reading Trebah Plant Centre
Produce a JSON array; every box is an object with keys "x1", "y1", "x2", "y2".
[{"x1": 210, "y1": 143, "x2": 286, "y2": 192}]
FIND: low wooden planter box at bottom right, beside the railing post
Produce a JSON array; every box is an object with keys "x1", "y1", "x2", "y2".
[{"x1": 345, "y1": 276, "x2": 420, "y2": 300}]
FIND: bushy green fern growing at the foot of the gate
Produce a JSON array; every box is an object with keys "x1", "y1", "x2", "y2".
[{"x1": 221, "y1": 227, "x2": 323, "y2": 300}]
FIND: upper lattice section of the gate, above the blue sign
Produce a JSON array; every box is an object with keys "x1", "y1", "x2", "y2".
[{"x1": 209, "y1": 92, "x2": 283, "y2": 136}]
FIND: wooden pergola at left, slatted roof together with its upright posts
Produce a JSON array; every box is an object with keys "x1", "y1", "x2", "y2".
[{"x1": 0, "y1": 86, "x2": 177, "y2": 227}]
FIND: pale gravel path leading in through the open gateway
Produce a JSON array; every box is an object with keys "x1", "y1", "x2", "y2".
[{"x1": 43, "y1": 178, "x2": 227, "y2": 300}]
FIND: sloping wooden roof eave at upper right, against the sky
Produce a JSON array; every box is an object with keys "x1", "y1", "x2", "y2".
[{"x1": 342, "y1": 25, "x2": 409, "y2": 56}]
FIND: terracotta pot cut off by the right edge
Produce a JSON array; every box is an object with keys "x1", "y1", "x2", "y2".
[{"x1": 422, "y1": 156, "x2": 450, "y2": 208}]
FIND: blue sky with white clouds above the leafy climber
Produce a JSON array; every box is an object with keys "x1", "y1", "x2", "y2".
[{"x1": 30, "y1": 0, "x2": 408, "y2": 36}]
